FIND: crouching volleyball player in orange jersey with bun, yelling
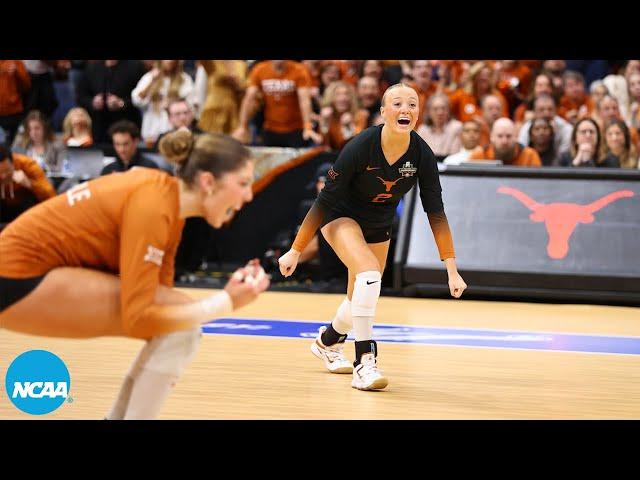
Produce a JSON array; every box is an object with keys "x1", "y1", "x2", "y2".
[{"x1": 0, "y1": 130, "x2": 269, "y2": 419}]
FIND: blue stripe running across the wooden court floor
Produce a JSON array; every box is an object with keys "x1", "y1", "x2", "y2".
[{"x1": 202, "y1": 318, "x2": 640, "y2": 355}]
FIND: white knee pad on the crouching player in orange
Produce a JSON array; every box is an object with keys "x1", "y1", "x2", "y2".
[{"x1": 142, "y1": 327, "x2": 202, "y2": 377}]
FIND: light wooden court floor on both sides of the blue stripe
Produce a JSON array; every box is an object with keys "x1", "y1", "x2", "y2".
[{"x1": 0, "y1": 290, "x2": 640, "y2": 419}]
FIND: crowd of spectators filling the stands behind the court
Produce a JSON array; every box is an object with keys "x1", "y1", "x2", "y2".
[{"x1": 0, "y1": 60, "x2": 640, "y2": 274}]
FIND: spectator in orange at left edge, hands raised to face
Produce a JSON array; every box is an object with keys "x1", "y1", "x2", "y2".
[{"x1": 0, "y1": 145, "x2": 56, "y2": 230}]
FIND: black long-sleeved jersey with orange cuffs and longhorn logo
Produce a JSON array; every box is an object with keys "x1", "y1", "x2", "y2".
[{"x1": 292, "y1": 126, "x2": 455, "y2": 260}]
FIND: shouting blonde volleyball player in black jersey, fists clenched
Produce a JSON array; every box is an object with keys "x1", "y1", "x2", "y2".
[{"x1": 279, "y1": 84, "x2": 467, "y2": 390}]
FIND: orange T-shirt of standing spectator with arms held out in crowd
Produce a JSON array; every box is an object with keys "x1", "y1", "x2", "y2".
[{"x1": 249, "y1": 61, "x2": 311, "y2": 133}]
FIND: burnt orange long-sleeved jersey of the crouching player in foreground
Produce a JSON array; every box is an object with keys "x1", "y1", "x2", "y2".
[{"x1": 0, "y1": 168, "x2": 184, "y2": 338}]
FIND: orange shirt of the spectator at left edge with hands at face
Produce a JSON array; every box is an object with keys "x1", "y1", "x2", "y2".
[{"x1": 0, "y1": 153, "x2": 56, "y2": 208}]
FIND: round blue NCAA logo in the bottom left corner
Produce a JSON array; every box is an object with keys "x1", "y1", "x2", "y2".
[{"x1": 5, "y1": 350, "x2": 71, "y2": 415}]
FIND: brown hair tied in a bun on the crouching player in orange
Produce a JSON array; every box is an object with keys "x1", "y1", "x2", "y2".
[{"x1": 158, "y1": 129, "x2": 252, "y2": 185}]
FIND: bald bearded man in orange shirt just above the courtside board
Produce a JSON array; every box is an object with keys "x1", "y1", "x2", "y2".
[{"x1": 469, "y1": 118, "x2": 542, "y2": 167}]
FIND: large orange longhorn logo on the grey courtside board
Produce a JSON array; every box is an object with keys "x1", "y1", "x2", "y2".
[{"x1": 498, "y1": 187, "x2": 633, "y2": 260}]
